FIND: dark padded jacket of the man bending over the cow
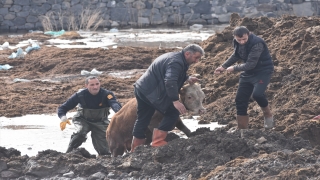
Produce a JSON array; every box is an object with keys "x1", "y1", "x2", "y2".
[{"x1": 134, "y1": 51, "x2": 189, "y2": 113}]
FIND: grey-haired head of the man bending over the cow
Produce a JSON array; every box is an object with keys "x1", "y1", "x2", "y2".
[{"x1": 183, "y1": 44, "x2": 204, "y2": 65}]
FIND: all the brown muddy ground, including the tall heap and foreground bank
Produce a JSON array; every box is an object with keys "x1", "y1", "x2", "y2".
[{"x1": 0, "y1": 14, "x2": 320, "y2": 179}]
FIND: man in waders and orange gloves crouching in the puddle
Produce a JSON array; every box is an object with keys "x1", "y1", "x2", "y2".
[{"x1": 58, "y1": 76, "x2": 121, "y2": 155}]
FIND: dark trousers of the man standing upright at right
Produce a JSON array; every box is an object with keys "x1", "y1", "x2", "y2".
[{"x1": 235, "y1": 69, "x2": 273, "y2": 115}]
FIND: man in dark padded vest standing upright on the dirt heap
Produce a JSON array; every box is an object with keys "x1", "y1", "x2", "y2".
[{"x1": 214, "y1": 26, "x2": 274, "y2": 129}]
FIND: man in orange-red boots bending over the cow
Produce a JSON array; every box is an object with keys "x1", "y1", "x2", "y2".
[{"x1": 131, "y1": 44, "x2": 204, "y2": 152}]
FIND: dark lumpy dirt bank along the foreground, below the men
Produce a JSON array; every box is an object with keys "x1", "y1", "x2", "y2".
[{"x1": 0, "y1": 129, "x2": 320, "y2": 179}]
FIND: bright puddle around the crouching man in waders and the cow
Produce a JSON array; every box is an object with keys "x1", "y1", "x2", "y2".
[{"x1": 0, "y1": 111, "x2": 221, "y2": 156}]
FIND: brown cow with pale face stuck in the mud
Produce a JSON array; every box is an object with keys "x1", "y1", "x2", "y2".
[{"x1": 106, "y1": 84, "x2": 205, "y2": 156}]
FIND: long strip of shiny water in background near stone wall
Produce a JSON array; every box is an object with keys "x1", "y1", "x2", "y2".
[{"x1": 0, "y1": 25, "x2": 227, "y2": 49}]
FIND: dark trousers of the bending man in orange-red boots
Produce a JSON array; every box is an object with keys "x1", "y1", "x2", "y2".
[{"x1": 132, "y1": 89, "x2": 179, "y2": 139}]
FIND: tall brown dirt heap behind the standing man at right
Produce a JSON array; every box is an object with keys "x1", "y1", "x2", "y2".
[{"x1": 198, "y1": 14, "x2": 320, "y2": 145}]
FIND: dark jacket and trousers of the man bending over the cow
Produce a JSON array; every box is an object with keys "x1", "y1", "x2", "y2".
[{"x1": 132, "y1": 51, "x2": 189, "y2": 139}]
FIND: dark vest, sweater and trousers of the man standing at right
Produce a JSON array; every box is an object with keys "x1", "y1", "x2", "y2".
[{"x1": 222, "y1": 33, "x2": 274, "y2": 115}]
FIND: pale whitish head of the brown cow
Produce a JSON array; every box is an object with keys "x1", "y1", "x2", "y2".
[{"x1": 179, "y1": 83, "x2": 206, "y2": 114}]
